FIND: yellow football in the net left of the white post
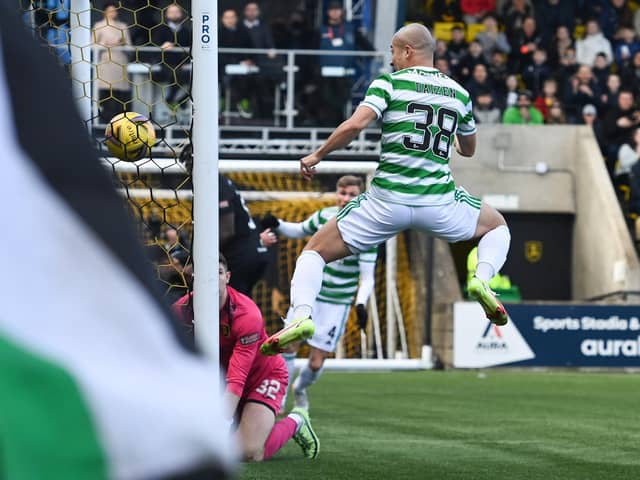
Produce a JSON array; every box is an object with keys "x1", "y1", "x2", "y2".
[{"x1": 104, "y1": 112, "x2": 156, "y2": 162}]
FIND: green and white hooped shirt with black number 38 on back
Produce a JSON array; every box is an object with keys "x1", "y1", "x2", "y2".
[{"x1": 362, "y1": 67, "x2": 476, "y2": 205}]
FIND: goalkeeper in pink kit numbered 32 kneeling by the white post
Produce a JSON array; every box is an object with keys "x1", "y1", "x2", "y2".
[{"x1": 173, "y1": 255, "x2": 320, "y2": 461}]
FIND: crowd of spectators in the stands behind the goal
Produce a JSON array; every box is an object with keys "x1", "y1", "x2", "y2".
[{"x1": 35, "y1": 0, "x2": 640, "y2": 230}]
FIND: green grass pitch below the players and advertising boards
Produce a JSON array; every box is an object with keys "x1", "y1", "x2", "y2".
[{"x1": 239, "y1": 370, "x2": 640, "y2": 480}]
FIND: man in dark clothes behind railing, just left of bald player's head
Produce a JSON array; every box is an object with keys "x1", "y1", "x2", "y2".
[{"x1": 318, "y1": 1, "x2": 373, "y2": 127}]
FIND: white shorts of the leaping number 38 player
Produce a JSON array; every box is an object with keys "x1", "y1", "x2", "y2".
[{"x1": 337, "y1": 187, "x2": 481, "y2": 253}]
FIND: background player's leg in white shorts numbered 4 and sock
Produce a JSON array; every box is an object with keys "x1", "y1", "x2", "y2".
[{"x1": 293, "y1": 301, "x2": 351, "y2": 409}]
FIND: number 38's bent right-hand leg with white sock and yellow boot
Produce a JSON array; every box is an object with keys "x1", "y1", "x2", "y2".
[{"x1": 467, "y1": 203, "x2": 511, "y2": 325}]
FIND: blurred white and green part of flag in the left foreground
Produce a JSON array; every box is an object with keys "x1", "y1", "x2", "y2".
[{"x1": 0, "y1": 43, "x2": 235, "y2": 480}]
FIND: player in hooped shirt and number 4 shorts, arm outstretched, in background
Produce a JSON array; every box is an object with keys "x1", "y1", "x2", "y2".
[{"x1": 261, "y1": 175, "x2": 378, "y2": 409}]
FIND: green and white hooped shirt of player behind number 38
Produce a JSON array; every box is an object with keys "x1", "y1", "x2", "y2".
[{"x1": 302, "y1": 206, "x2": 378, "y2": 305}]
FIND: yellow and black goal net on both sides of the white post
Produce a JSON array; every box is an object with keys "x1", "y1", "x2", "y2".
[{"x1": 21, "y1": 0, "x2": 430, "y2": 368}]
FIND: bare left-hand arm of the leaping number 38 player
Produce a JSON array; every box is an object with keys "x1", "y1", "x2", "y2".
[{"x1": 300, "y1": 105, "x2": 378, "y2": 180}]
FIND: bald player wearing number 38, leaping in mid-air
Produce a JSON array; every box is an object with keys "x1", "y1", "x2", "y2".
[{"x1": 261, "y1": 23, "x2": 511, "y2": 355}]
